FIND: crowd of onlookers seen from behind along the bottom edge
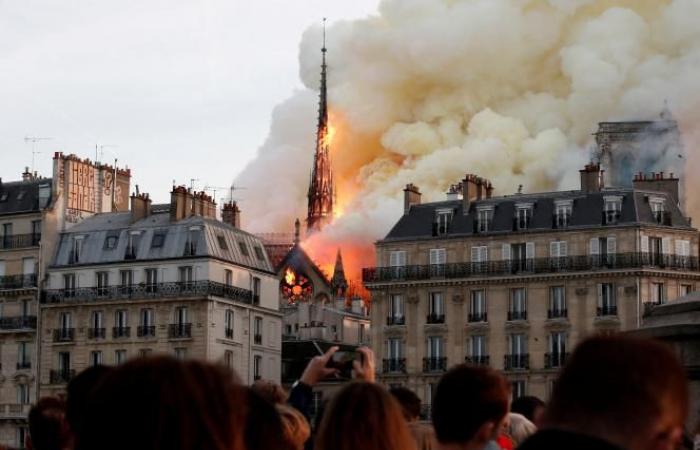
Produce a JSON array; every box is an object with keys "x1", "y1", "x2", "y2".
[{"x1": 26, "y1": 336, "x2": 692, "y2": 450}]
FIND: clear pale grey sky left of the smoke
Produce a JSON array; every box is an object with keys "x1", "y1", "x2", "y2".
[{"x1": 0, "y1": 0, "x2": 378, "y2": 202}]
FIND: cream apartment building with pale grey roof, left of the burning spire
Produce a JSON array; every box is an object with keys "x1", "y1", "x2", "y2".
[{"x1": 36, "y1": 186, "x2": 282, "y2": 396}]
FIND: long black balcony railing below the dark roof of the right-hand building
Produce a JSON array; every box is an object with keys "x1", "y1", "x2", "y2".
[{"x1": 362, "y1": 252, "x2": 700, "y2": 283}]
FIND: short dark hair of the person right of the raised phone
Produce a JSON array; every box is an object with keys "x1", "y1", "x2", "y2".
[{"x1": 432, "y1": 364, "x2": 510, "y2": 444}]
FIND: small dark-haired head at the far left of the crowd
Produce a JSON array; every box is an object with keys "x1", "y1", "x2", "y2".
[{"x1": 26, "y1": 397, "x2": 72, "y2": 450}]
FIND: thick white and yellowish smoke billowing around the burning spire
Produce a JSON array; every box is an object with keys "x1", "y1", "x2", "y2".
[{"x1": 236, "y1": 0, "x2": 700, "y2": 272}]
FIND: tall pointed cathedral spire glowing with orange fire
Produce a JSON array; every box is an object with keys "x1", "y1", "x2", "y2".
[{"x1": 306, "y1": 19, "x2": 335, "y2": 235}]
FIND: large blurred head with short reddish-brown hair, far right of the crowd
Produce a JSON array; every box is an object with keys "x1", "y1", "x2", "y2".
[{"x1": 544, "y1": 335, "x2": 688, "y2": 450}]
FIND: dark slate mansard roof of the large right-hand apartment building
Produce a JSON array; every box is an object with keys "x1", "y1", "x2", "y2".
[{"x1": 380, "y1": 188, "x2": 692, "y2": 242}]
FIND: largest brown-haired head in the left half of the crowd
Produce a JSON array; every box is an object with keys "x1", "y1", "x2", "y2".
[{"x1": 76, "y1": 356, "x2": 247, "y2": 450}]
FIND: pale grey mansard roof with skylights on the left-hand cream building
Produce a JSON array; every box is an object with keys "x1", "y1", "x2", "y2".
[{"x1": 52, "y1": 212, "x2": 273, "y2": 273}]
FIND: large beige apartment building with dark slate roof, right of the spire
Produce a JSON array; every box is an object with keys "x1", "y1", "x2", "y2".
[{"x1": 363, "y1": 164, "x2": 700, "y2": 410}]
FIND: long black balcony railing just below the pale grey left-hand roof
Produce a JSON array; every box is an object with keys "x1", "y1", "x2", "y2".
[{"x1": 41, "y1": 281, "x2": 253, "y2": 304}]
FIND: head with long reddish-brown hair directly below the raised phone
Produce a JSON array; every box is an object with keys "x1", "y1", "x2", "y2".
[{"x1": 315, "y1": 382, "x2": 415, "y2": 450}]
